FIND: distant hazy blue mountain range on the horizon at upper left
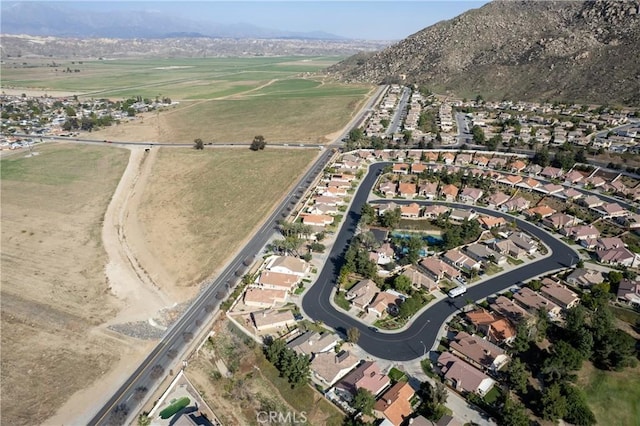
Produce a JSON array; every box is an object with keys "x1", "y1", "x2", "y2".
[{"x1": 0, "y1": 1, "x2": 345, "y2": 40}]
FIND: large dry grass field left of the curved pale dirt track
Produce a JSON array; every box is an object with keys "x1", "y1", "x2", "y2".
[{"x1": 0, "y1": 145, "x2": 129, "y2": 425}]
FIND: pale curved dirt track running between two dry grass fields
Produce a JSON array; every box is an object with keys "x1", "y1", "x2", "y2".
[{"x1": 102, "y1": 148, "x2": 172, "y2": 325}]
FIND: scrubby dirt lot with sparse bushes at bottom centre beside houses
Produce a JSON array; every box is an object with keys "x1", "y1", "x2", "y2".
[{"x1": 186, "y1": 317, "x2": 343, "y2": 426}]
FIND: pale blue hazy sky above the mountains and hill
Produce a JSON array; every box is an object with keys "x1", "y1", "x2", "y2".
[{"x1": 47, "y1": 0, "x2": 487, "y2": 40}]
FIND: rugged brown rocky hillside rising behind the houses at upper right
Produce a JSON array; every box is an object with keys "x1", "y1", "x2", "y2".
[{"x1": 329, "y1": 0, "x2": 640, "y2": 105}]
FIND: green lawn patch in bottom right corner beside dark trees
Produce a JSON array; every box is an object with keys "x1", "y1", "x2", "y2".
[{"x1": 578, "y1": 363, "x2": 640, "y2": 426}]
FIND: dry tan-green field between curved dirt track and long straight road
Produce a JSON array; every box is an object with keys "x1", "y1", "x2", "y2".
[{"x1": 134, "y1": 146, "x2": 318, "y2": 297}]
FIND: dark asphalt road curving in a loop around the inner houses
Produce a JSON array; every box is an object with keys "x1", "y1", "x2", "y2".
[{"x1": 302, "y1": 163, "x2": 579, "y2": 361}]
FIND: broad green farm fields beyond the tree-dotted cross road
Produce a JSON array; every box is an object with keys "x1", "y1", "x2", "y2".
[{"x1": 2, "y1": 57, "x2": 374, "y2": 143}]
